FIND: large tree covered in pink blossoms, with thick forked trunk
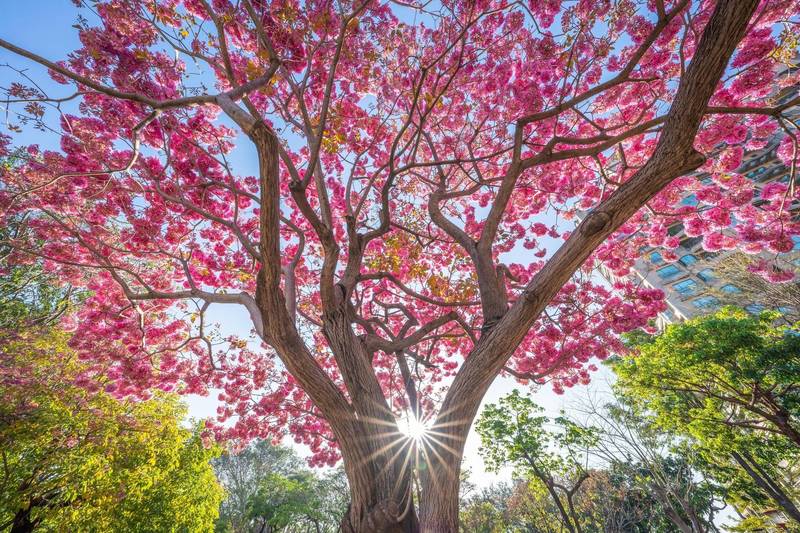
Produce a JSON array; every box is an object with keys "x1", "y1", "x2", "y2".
[{"x1": 0, "y1": 0, "x2": 800, "y2": 531}]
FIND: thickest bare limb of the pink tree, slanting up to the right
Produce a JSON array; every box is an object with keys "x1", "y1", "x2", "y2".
[{"x1": 436, "y1": 0, "x2": 758, "y2": 484}]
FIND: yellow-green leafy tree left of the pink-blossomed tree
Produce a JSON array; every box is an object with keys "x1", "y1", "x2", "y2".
[{"x1": 0, "y1": 328, "x2": 223, "y2": 533}]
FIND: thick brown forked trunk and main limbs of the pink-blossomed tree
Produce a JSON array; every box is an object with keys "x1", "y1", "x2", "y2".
[{"x1": 252, "y1": 0, "x2": 759, "y2": 533}]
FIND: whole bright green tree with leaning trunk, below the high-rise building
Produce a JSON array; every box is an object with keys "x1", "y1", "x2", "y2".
[{"x1": 613, "y1": 308, "x2": 800, "y2": 524}]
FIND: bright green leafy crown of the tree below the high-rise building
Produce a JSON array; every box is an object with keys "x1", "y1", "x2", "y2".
[{"x1": 614, "y1": 308, "x2": 800, "y2": 447}]
